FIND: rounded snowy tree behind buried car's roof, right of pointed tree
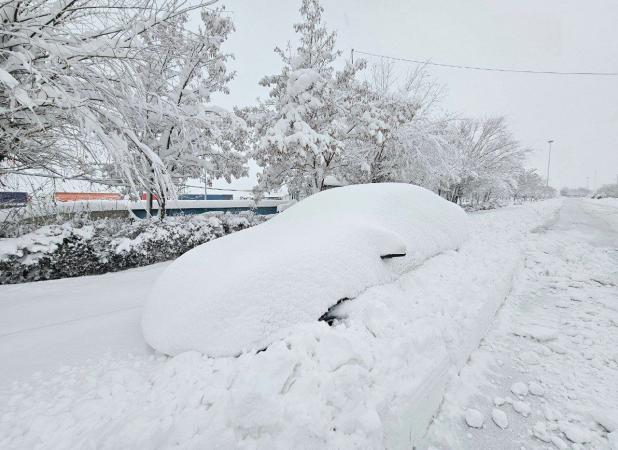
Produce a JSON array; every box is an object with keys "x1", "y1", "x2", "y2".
[{"x1": 346, "y1": 62, "x2": 445, "y2": 183}]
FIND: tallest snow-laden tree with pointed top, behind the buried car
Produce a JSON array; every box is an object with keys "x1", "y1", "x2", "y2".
[{"x1": 253, "y1": 0, "x2": 364, "y2": 196}]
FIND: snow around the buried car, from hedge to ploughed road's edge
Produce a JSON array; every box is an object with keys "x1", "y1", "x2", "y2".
[{"x1": 0, "y1": 200, "x2": 560, "y2": 449}]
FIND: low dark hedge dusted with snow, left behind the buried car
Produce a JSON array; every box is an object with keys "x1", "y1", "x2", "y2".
[{"x1": 0, "y1": 212, "x2": 265, "y2": 284}]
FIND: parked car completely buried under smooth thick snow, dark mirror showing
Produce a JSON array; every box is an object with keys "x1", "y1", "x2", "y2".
[{"x1": 142, "y1": 183, "x2": 468, "y2": 356}]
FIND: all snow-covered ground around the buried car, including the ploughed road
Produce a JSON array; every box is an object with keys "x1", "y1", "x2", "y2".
[{"x1": 0, "y1": 200, "x2": 618, "y2": 448}]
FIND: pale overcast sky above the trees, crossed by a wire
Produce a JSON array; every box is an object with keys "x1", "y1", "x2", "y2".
[{"x1": 208, "y1": 0, "x2": 618, "y2": 188}]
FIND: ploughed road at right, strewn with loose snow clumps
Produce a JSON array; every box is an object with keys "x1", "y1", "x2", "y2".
[{"x1": 425, "y1": 199, "x2": 618, "y2": 450}]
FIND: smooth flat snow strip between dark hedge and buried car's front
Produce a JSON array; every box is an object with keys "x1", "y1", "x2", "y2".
[{"x1": 0, "y1": 262, "x2": 169, "y2": 384}]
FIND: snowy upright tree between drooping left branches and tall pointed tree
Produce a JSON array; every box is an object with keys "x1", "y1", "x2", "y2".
[{"x1": 109, "y1": 9, "x2": 247, "y2": 215}]
